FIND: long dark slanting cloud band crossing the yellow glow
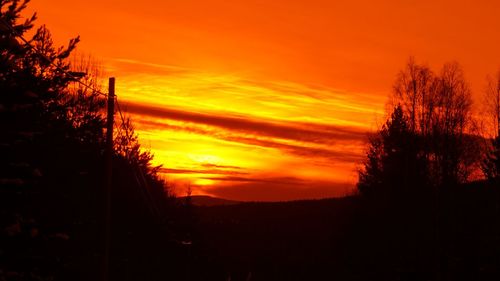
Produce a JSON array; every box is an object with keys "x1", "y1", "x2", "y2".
[{"x1": 119, "y1": 104, "x2": 366, "y2": 164}]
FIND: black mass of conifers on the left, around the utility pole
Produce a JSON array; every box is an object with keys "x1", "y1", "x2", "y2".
[{"x1": 0, "y1": 0, "x2": 193, "y2": 280}]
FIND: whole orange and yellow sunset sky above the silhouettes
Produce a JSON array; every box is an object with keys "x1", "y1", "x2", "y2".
[{"x1": 24, "y1": 0, "x2": 500, "y2": 200}]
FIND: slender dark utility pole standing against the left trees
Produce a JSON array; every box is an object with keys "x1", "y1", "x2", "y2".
[{"x1": 102, "y1": 77, "x2": 115, "y2": 281}]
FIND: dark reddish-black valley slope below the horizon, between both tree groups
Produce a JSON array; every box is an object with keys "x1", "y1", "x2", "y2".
[{"x1": 192, "y1": 198, "x2": 359, "y2": 280}]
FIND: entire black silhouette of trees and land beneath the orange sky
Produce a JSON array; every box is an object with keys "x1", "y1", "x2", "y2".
[{"x1": 0, "y1": 0, "x2": 500, "y2": 281}]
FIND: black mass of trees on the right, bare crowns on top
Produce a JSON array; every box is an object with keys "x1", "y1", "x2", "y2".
[{"x1": 352, "y1": 59, "x2": 500, "y2": 280}]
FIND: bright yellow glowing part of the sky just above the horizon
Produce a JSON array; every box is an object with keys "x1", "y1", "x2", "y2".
[{"x1": 109, "y1": 60, "x2": 385, "y2": 199}]
